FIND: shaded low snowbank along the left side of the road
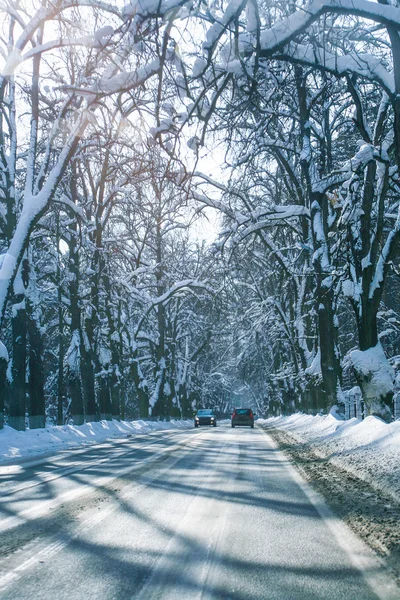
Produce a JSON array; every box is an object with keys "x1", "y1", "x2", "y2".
[{"x1": 0, "y1": 420, "x2": 193, "y2": 464}]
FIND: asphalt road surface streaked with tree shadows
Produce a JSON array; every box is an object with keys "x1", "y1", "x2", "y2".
[{"x1": 0, "y1": 425, "x2": 400, "y2": 600}]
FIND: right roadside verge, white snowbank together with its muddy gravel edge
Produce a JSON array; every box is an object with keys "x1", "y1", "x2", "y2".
[{"x1": 257, "y1": 413, "x2": 400, "y2": 584}]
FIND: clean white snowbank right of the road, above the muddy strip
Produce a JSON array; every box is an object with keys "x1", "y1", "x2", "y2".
[{"x1": 257, "y1": 413, "x2": 400, "y2": 501}]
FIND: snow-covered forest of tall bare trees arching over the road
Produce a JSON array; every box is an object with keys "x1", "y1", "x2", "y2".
[{"x1": 0, "y1": 0, "x2": 400, "y2": 430}]
